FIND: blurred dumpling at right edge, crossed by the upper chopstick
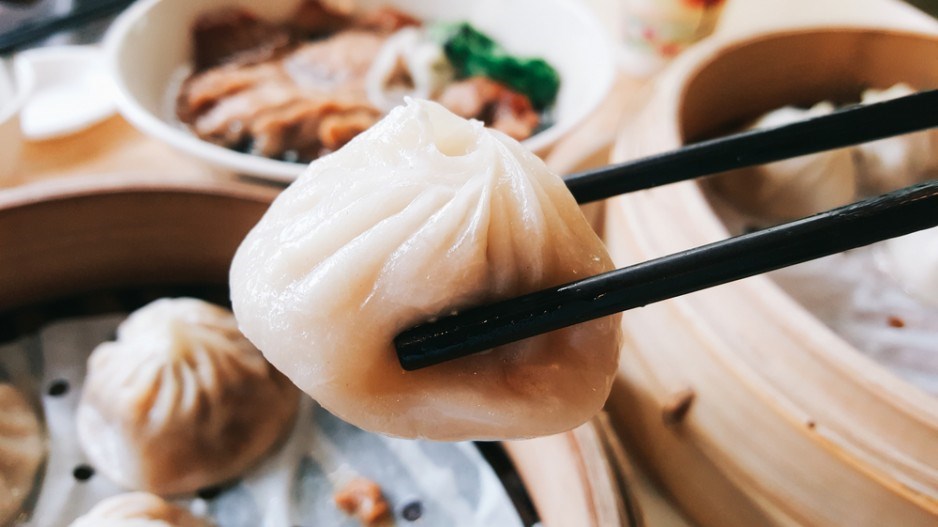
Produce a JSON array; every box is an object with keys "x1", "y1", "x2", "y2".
[{"x1": 855, "y1": 83, "x2": 938, "y2": 194}]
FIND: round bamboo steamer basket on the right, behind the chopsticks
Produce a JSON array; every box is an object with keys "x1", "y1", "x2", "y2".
[{"x1": 606, "y1": 28, "x2": 938, "y2": 527}]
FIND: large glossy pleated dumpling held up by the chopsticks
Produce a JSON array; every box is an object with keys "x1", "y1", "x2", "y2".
[{"x1": 231, "y1": 101, "x2": 619, "y2": 440}]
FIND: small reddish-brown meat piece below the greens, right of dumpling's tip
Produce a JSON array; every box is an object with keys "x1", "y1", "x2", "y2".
[{"x1": 439, "y1": 77, "x2": 540, "y2": 141}]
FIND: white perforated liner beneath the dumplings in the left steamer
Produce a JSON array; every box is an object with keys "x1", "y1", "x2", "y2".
[{"x1": 0, "y1": 292, "x2": 523, "y2": 527}]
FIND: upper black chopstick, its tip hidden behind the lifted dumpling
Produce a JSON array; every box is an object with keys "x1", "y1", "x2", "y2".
[{"x1": 565, "y1": 90, "x2": 938, "y2": 203}]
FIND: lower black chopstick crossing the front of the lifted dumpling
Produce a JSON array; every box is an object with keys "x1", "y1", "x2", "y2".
[{"x1": 394, "y1": 181, "x2": 938, "y2": 370}]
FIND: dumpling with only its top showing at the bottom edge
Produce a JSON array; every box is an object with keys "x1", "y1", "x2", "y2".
[{"x1": 69, "y1": 492, "x2": 211, "y2": 527}]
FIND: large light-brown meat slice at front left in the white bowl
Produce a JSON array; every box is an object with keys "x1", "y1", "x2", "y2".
[{"x1": 176, "y1": 30, "x2": 385, "y2": 162}]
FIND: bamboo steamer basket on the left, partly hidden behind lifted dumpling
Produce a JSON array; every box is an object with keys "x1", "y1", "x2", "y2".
[{"x1": 0, "y1": 177, "x2": 641, "y2": 527}]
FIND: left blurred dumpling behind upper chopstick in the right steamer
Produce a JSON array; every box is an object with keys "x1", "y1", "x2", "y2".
[{"x1": 713, "y1": 102, "x2": 857, "y2": 219}]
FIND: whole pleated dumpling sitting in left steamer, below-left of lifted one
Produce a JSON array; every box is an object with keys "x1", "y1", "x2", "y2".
[{"x1": 77, "y1": 298, "x2": 299, "y2": 495}]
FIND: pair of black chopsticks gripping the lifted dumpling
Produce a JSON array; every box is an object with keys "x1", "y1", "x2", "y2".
[{"x1": 394, "y1": 90, "x2": 938, "y2": 370}]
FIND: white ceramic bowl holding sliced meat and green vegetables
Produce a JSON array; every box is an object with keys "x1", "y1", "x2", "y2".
[{"x1": 104, "y1": 0, "x2": 615, "y2": 181}]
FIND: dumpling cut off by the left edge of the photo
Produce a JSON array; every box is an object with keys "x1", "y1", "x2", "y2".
[{"x1": 0, "y1": 383, "x2": 43, "y2": 525}]
